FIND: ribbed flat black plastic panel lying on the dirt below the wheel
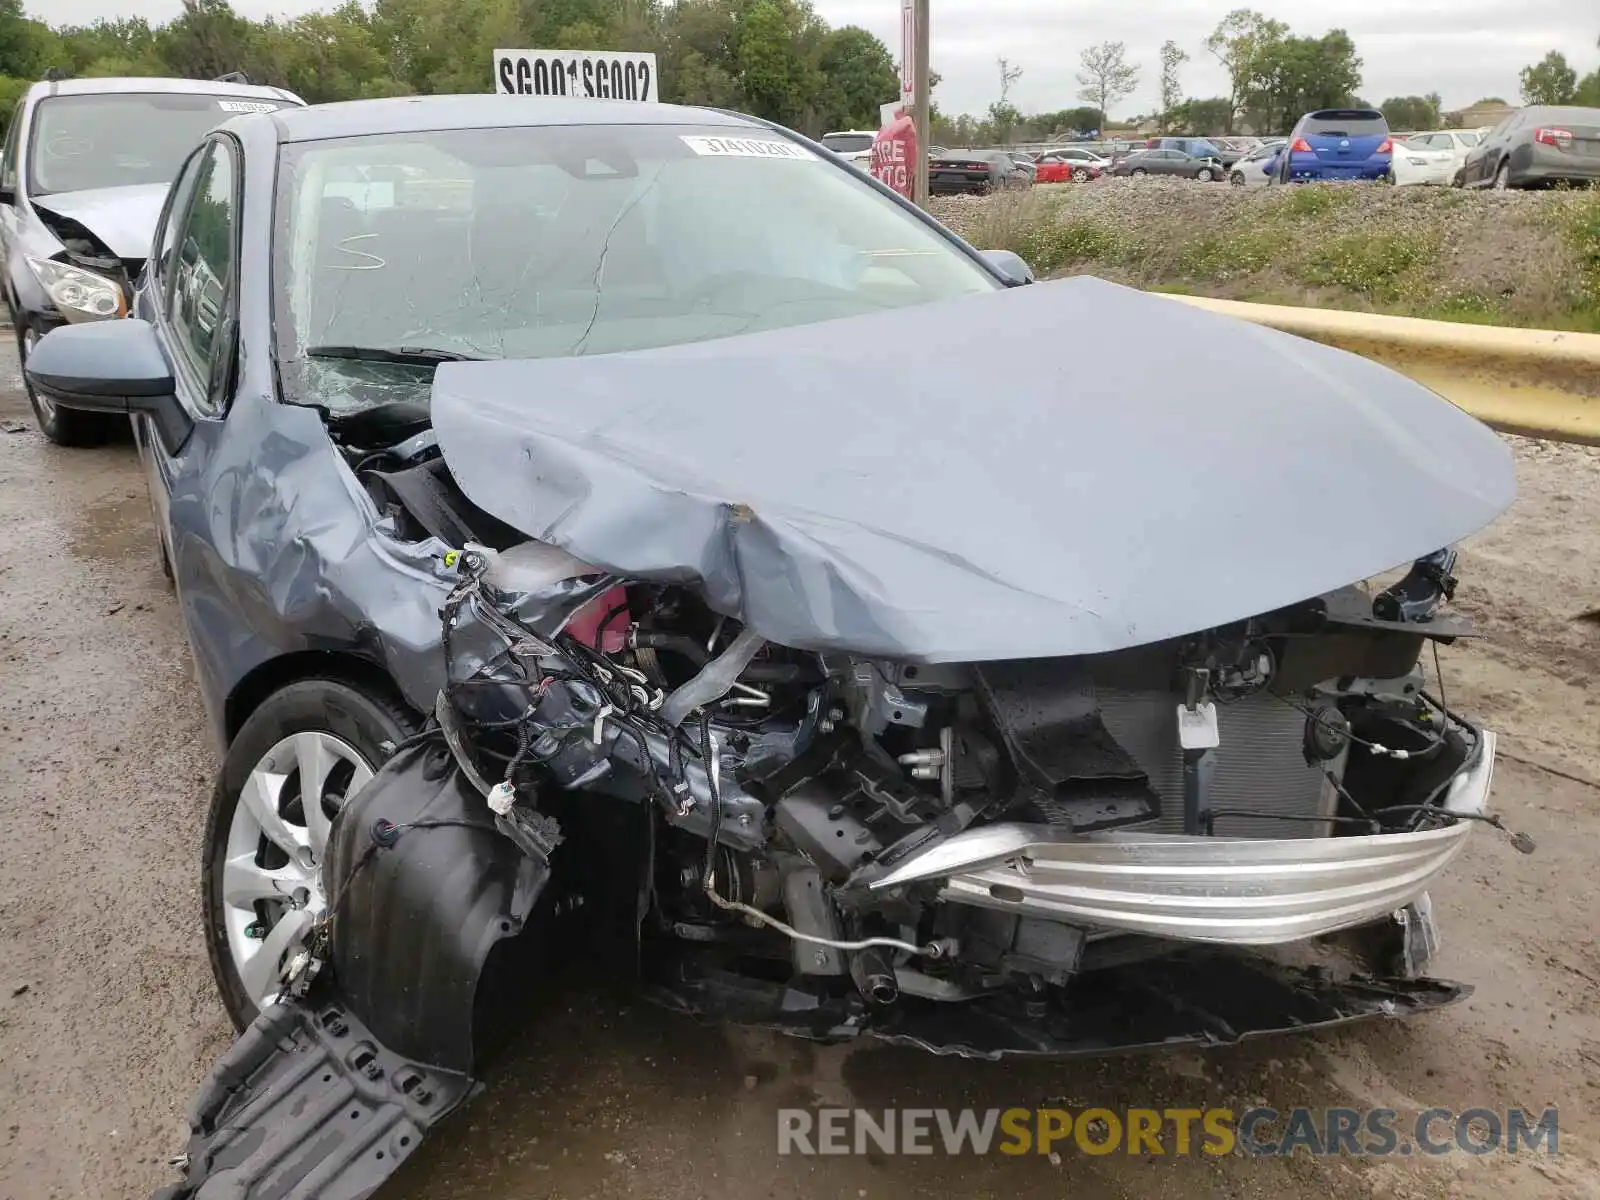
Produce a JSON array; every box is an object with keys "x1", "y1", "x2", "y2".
[{"x1": 154, "y1": 979, "x2": 480, "y2": 1200}]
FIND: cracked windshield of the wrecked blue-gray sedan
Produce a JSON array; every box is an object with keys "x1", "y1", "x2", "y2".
[{"x1": 274, "y1": 125, "x2": 998, "y2": 414}]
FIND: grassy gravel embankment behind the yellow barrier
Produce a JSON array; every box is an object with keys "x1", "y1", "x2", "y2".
[{"x1": 933, "y1": 179, "x2": 1600, "y2": 333}]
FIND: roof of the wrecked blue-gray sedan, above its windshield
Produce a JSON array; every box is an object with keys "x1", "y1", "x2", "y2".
[{"x1": 269, "y1": 93, "x2": 768, "y2": 142}]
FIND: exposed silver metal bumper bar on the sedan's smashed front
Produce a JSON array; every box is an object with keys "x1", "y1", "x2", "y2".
[{"x1": 869, "y1": 731, "x2": 1494, "y2": 946}]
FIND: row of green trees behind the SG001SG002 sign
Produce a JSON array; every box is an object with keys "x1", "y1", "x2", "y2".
[{"x1": 25, "y1": 0, "x2": 898, "y2": 124}]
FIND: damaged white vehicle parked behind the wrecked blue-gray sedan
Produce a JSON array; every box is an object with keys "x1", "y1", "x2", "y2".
[{"x1": 0, "y1": 78, "x2": 302, "y2": 445}]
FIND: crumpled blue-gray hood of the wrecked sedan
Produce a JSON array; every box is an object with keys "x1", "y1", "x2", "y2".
[{"x1": 434, "y1": 278, "x2": 1515, "y2": 662}]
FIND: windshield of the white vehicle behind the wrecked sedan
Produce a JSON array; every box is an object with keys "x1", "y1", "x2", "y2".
[{"x1": 27, "y1": 91, "x2": 288, "y2": 197}]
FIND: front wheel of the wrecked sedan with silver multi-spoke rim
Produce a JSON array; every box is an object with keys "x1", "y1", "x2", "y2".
[{"x1": 200, "y1": 678, "x2": 416, "y2": 1030}]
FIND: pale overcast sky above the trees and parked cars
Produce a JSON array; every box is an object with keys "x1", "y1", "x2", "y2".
[{"x1": 24, "y1": 0, "x2": 1600, "y2": 115}]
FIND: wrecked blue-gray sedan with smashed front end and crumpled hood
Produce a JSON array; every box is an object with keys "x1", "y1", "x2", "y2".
[{"x1": 29, "y1": 96, "x2": 1526, "y2": 1197}]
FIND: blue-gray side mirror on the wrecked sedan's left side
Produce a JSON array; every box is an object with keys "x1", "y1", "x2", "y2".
[{"x1": 27, "y1": 317, "x2": 194, "y2": 453}]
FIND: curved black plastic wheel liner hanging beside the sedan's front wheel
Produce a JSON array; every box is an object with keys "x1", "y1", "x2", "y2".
[{"x1": 323, "y1": 734, "x2": 550, "y2": 1074}]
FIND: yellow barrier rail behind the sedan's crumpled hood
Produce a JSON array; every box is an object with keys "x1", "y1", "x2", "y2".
[{"x1": 1171, "y1": 296, "x2": 1600, "y2": 445}]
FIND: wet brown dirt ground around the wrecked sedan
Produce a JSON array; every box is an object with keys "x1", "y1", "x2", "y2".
[{"x1": 0, "y1": 338, "x2": 1600, "y2": 1200}]
